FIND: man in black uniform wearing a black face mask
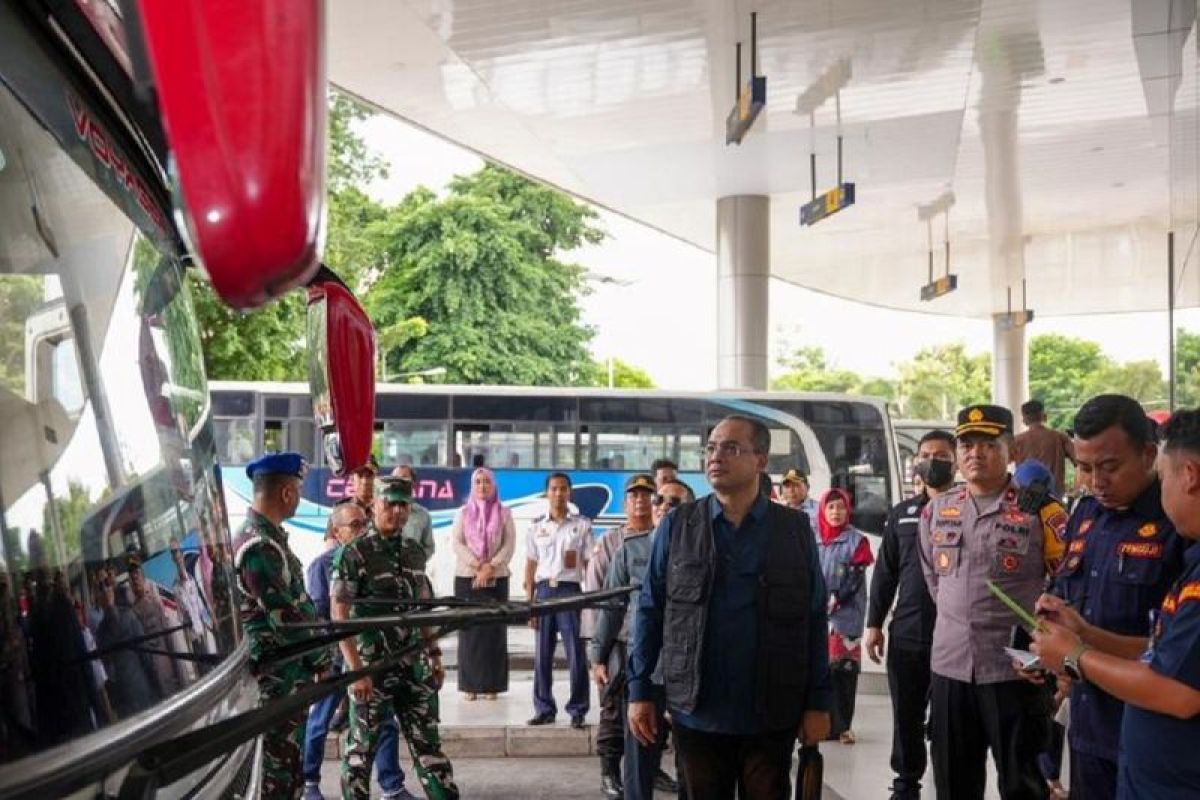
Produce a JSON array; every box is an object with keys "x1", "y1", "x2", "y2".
[{"x1": 863, "y1": 431, "x2": 954, "y2": 800}]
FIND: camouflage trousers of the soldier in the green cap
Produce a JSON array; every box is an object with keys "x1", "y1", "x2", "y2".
[{"x1": 342, "y1": 658, "x2": 458, "y2": 800}]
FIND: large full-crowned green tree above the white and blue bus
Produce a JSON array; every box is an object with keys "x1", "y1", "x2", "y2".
[{"x1": 367, "y1": 164, "x2": 605, "y2": 385}]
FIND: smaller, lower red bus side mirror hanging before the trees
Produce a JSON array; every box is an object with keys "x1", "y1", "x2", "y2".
[{"x1": 308, "y1": 267, "x2": 376, "y2": 476}]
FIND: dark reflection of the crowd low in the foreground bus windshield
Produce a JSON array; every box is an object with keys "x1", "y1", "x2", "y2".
[{"x1": 0, "y1": 531, "x2": 235, "y2": 763}]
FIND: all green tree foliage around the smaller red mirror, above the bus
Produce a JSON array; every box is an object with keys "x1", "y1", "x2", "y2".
[{"x1": 191, "y1": 94, "x2": 604, "y2": 384}]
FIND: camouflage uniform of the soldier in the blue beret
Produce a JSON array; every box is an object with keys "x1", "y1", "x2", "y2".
[{"x1": 234, "y1": 509, "x2": 330, "y2": 800}]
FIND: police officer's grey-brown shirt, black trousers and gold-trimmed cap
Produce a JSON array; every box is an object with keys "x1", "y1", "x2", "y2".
[{"x1": 920, "y1": 405, "x2": 1066, "y2": 800}]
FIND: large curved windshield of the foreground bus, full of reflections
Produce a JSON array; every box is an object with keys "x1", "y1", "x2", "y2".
[{"x1": 0, "y1": 88, "x2": 238, "y2": 763}]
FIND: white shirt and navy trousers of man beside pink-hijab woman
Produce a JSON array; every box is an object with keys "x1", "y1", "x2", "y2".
[{"x1": 526, "y1": 503, "x2": 592, "y2": 721}]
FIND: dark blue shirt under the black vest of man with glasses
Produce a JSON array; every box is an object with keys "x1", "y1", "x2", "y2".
[{"x1": 629, "y1": 495, "x2": 830, "y2": 735}]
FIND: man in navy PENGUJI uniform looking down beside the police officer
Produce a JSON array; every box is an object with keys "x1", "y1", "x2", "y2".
[{"x1": 1052, "y1": 395, "x2": 1186, "y2": 800}]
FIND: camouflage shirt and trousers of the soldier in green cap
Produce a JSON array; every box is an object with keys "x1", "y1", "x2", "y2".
[{"x1": 330, "y1": 527, "x2": 458, "y2": 800}]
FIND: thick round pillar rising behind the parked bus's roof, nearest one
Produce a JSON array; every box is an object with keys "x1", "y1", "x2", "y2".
[{"x1": 716, "y1": 194, "x2": 770, "y2": 389}]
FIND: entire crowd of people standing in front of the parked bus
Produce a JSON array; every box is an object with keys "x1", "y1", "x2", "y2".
[{"x1": 226, "y1": 395, "x2": 1200, "y2": 800}]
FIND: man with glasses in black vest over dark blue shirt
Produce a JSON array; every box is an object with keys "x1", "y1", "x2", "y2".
[{"x1": 629, "y1": 416, "x2": 830, "y2": 800}]
